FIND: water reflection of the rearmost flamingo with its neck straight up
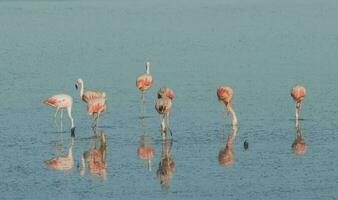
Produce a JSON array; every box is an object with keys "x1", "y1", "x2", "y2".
[{"x1": 137, "y1": 115, "x2": 154, "y2": 171}]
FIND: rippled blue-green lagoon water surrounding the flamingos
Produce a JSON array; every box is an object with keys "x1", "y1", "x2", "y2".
[{"x1": 0, "y1": 0, "x2": 338, "y2": 199}]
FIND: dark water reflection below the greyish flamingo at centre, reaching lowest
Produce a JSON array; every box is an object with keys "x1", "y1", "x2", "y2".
[{"x1": 156, "y1": 139, "x2": 175, "y2": 191}]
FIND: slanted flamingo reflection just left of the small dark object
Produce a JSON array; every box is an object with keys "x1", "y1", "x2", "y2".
[{"x1": 218, "y1": 126, "x2": 237, "y2": 166}]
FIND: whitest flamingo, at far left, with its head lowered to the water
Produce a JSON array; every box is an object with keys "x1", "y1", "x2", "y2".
[{"x1": 43, "y1": 94, "x2": 75, "y2": 137}]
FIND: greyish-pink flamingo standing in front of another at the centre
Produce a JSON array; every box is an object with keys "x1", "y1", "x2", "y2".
[{"x1": 155, "y1": 97, "x2": 172, "y2": 139}]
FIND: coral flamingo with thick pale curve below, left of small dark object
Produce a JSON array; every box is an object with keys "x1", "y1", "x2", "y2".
[{"x1": 217, "y1": 86, "x2": 237, "y2": 126}]
